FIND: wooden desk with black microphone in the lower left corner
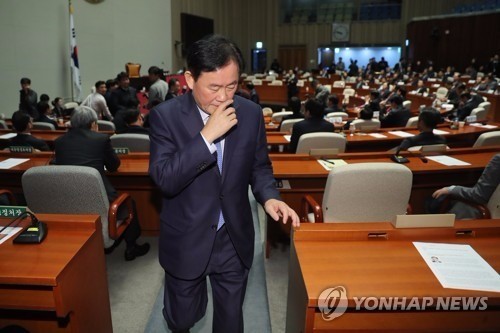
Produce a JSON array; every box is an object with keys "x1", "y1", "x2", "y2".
[{"x1": 0, "y1": 214, "x2": 113, "y2": 333}]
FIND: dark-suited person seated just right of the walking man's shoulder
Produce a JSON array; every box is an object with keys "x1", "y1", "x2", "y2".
[{"x1": 289, "y1": 98, "x2": 335, "y2": 153}]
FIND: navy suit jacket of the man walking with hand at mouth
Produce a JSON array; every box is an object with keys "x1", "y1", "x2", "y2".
[{"x1": 149, "y1": 92, "x2": 279, "y2": 279}]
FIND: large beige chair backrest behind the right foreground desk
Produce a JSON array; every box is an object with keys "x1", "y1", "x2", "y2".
[{"x1": 322, "y1": 163, "x2": 413, "y2": 222}]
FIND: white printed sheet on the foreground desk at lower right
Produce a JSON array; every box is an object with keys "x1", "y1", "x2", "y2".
[{"x1": 413, "y1": 242, "x2": 500, "y2": 292}]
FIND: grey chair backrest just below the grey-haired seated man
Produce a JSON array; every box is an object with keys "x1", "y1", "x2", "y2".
[{"x1": 22, "y1": 165, "x2": 113, "y2": 247}]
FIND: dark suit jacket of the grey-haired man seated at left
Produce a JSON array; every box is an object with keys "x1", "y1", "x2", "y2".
[{"x1": 54, "y1": 128, "x2": 120, "y2": 201}]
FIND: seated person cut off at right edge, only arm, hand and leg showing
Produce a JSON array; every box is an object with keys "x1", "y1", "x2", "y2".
[{"x1": 427, "y1": 154, "x2": 500, "y2": 219}]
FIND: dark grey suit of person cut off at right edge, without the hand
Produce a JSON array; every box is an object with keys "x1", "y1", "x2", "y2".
[{"x1": 450, "y1": 154, "x2": 500, "y2": 218}]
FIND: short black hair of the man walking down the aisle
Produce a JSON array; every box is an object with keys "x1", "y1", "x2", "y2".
[{"x1": 186, "y1": 35, "x2": 245, "y2": 81}]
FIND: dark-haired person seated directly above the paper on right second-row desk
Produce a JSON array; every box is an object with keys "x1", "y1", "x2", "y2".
[{"x1": 398, "y1": 107, "x2": 446, "y2": 151}]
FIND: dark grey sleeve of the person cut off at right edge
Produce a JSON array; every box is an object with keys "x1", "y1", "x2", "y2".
[{"x1": 450, "y1": 154, "x2": 500, "y2": 204}]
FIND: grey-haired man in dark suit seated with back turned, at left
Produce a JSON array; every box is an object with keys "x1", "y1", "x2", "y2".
[{"x1": 53, "y1": 106, "x2": 149, "y2": 261}]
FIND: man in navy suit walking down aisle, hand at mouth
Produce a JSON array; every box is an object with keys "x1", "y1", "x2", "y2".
[{"x1": 149, "y1": 35, "x2": 299, "y2": 332}]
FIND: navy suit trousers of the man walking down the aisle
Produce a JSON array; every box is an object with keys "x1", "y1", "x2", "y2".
[{"x1": 163, "y1": 225, "x2": 249, "y2": 333}]
